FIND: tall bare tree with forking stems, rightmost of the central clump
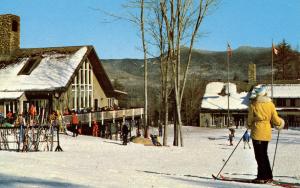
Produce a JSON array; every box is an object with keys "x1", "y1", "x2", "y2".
[{"x1": 160, "y1": 0, "x2": 216, "y2": 146}]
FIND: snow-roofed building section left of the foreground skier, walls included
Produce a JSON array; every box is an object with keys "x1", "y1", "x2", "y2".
[{"x1": 200, "y1": 82, "x2": 250, "y2": 127}]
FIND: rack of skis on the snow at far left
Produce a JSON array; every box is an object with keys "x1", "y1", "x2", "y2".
[{"x1": 0, "y1": 125, "x2": 62, "y2": 152}]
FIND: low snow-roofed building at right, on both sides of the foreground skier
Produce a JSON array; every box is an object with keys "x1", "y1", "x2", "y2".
[{"x1": 200, "y1": 82, "x2": 300, "y2": 128}]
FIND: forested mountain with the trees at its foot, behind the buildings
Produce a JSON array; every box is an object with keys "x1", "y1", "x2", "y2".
[{"x1": 102, "y1": 46, "x2": 300, "y2": 110}]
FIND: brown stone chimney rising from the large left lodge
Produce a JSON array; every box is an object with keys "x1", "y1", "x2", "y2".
[{"x1": 0, "y1": 14, "x2": 20, "y2": 57}]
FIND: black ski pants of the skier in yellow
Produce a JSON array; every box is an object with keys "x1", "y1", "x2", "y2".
[{"x1": 252, "y1": 140, "x2": 273, "y2": 180}]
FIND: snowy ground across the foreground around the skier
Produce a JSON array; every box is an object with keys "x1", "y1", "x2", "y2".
[{"x1": 0, "y1": 127, "x2": 300, "y2": 188}]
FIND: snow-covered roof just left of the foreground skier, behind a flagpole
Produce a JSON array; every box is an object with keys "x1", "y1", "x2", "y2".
[{"x1": 201, "y1": 82, "x2": 249, "y2": 110}]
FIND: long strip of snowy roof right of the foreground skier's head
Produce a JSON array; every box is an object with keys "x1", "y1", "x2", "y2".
[{"x1": 251, "y1": 84, "x2": 300, "y2": 98}]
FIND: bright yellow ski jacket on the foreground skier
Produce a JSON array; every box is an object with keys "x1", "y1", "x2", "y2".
[{"x1": 248, "y1": 96, "x2": 284, "y2": 141}]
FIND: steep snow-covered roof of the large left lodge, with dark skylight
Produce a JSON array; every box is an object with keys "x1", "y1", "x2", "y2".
[{"x1": 0, "y1": 46, "x2": 88, "y2": 91}]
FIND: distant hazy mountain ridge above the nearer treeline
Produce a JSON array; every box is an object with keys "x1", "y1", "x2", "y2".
[{"x1": 101, "y1": 46, "x2": 299, "y2": 94}]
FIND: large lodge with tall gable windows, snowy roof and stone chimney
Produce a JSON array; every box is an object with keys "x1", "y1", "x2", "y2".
[{"x1": 0, "y1": 14, "x2": 142, "y2": 122}]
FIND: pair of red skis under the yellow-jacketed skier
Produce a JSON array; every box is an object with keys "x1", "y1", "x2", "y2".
[{"x1": 212, "y1": 174, "x2": 300, "y2": 188}]
